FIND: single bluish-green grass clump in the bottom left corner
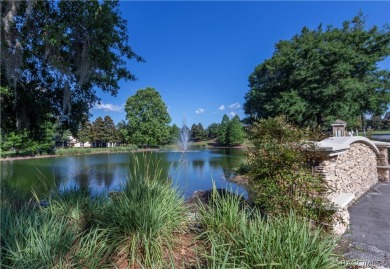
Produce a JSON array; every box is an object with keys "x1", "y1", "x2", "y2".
[{"x1": 0, "y1": 201, "x2": 77, "y2": 268}]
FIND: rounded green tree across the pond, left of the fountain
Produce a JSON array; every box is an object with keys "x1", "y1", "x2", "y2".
[{"x1": 125, "y1": 88, "x2": 171, "y2": 146}]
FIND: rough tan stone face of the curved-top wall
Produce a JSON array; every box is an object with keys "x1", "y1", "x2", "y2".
[{"x1": 316, "y1": 142, "x2": 378, "y2": 199}]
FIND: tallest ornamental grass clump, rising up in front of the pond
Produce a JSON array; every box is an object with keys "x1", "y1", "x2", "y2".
[{"x1": 101, "y1": 153, "x2": 187, "y2": 268}]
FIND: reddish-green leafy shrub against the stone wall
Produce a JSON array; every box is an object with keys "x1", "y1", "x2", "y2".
[{"x1": 246, "y1": 118, "x2": 332, "y2": 221}]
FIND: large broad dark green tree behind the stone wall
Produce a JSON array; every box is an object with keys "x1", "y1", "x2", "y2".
[{"x1": 244, "y1": 14, "x2": 390, "y2": 128}]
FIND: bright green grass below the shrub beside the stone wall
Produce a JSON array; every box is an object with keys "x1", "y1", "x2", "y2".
[{"x1": 200, "y1": 188, "x2": 341, "y2": 269}]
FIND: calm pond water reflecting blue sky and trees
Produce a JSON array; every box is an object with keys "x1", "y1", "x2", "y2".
[{"x1": 1, "y1": 149, "x2": 247, "y2": 198}]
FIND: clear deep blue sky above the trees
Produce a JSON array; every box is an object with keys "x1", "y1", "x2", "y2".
[{"x1": 90, "y1": 1, "x2": 390, "y2": 128}]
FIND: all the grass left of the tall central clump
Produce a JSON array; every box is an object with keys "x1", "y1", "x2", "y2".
[{"x1": 0, "y1": 188, "x2": 116, "y2": 268}]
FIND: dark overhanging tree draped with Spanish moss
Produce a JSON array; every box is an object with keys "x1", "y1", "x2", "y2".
[{"x1": 0, "y1": 0, "x2": 142, "y2": 139}]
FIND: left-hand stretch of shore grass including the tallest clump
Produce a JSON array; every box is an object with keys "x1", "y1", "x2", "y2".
[{"x1": 0, "y1": 152, "x2": 187, "y2": 268}]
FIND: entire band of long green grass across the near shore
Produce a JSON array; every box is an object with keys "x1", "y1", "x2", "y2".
[{"x1": 0, "y1": 155, "x2": 340, "y2": 269}]
